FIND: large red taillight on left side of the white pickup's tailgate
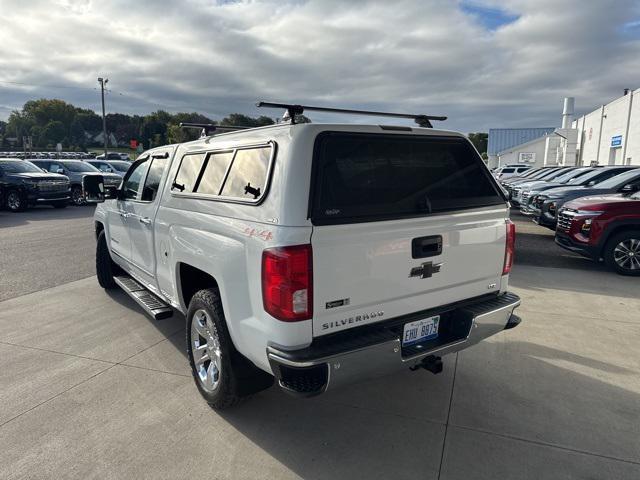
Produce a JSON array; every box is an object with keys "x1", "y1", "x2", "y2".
[{"x1": 262, "y1": 245, "x2": 313, "y2": 322}]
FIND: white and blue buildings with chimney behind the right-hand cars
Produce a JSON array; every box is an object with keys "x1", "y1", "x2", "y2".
[{"x1": 487, "y1": 89, "x2": 640, "y2": 168}]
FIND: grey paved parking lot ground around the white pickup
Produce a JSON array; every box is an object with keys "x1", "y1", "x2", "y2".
[{"x1": 0, "y1": 209, "x2": 640, "y2": 479}]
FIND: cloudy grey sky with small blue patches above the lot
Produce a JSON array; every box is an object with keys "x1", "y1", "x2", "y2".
[{"x1": 0, "y1": 0, "x2": 640, "y2": 132}]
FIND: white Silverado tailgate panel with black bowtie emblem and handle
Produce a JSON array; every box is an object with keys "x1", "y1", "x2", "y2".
[{"x1": 311, "y1": 207, "x2": 506, "y2": 336}]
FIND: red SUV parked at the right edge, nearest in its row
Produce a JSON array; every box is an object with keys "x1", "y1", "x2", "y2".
[{"x1": 556, "y1": 192, "x2": 640, "y2": 275}]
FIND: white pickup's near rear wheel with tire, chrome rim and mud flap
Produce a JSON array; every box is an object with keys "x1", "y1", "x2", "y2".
[{"x1": 186, "y1": 289, "x2": 273, "y2": 410}]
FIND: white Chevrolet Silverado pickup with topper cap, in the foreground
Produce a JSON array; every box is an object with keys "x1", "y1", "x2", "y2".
[{"x1": 85, "y1": 104, "x2": 520, "y2": 409}]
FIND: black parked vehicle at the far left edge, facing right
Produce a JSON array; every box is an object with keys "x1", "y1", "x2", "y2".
[{"x1": 0, "y1": 159, "x2": 70, "y2": 212}]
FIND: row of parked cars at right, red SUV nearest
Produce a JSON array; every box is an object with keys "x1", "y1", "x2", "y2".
[{"x1": 501, "y1": 166, "x2": 640, "y2": 275}]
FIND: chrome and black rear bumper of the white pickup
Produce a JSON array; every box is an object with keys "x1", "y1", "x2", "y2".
[{"x1": 267, "y1": 293, "x2": 520, "y2": 396}]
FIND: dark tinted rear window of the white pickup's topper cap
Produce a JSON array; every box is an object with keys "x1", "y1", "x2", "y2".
[{"x1": 310, "y1": 132, "x2": 505, "y2": 225}]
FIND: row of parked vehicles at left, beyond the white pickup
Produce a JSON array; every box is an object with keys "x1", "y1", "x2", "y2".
[{"x1": 0, "y1": 158, "x2": 131, "y2": 212}]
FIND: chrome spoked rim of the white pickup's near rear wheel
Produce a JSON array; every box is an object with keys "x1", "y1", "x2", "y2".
[{"x1": 191, "y1": 309, "x2": 222, "y2": 393}]
